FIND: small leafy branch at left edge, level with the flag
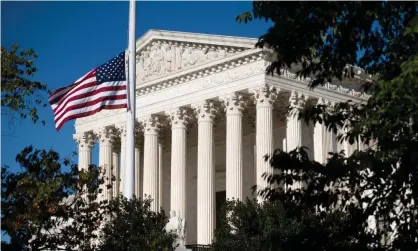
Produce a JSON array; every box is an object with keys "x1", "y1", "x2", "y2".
[{"x1": 1, "y1": 44, "x2": 47, "y2": 124}]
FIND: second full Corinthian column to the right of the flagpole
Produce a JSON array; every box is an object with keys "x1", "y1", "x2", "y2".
[{"x1": 166, "y1": 108, "x2": 189, "y2": 219}]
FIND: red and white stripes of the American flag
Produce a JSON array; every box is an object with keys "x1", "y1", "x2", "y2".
[{"x1": 49, "y1": 69, "x2": 127, "y2": 131}]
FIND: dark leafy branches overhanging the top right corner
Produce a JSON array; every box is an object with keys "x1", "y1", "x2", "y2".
[{"x1": 237, "y1": 1, "x2": 418, "y2": 86}]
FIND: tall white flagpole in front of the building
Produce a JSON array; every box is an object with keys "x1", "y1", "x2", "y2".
[{"x1": 123, "y1": 0, "x2": 136, "y2": 199}]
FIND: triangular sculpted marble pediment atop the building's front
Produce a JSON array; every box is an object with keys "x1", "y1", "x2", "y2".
[{"x1": 136, "y1": 30, "x2": 257, "y2": 83}]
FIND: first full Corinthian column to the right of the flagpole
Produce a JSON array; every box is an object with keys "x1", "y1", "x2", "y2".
[{"x1": 142, "y1": 116, "x2": 160, "y2": 212}]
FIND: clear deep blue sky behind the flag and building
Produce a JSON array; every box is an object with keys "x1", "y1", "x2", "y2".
[{"x1": 1, "y1": 1, "x2": 268, "y2": 170}]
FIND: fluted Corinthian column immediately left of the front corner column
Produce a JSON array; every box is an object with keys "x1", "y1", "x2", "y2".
[{"x1": 221, "y1": 93, "x2": 244, "y2": 201}]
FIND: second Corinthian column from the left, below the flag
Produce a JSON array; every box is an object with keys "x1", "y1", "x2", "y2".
[{"x1": 97, "y1": 127, "x2": 115, "y2": 201}]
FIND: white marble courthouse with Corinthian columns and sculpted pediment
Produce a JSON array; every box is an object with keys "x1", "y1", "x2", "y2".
[{"x1": 74, "y1": 30, "x2": 368, "y2": 245}]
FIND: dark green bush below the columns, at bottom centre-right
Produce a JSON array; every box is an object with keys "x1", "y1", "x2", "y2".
[{"x1": 213, "y1": 199, "x2": 372, "y2": 251}]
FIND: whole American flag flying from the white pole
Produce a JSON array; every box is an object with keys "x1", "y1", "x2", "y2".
[{"x1": 49, "y1": 52, "x2": 128, "y2": 131}]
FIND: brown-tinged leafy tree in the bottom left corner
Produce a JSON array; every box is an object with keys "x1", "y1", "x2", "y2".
[{"x1": 1, "y1": 147, "x2": 106, "y2": 250}]
